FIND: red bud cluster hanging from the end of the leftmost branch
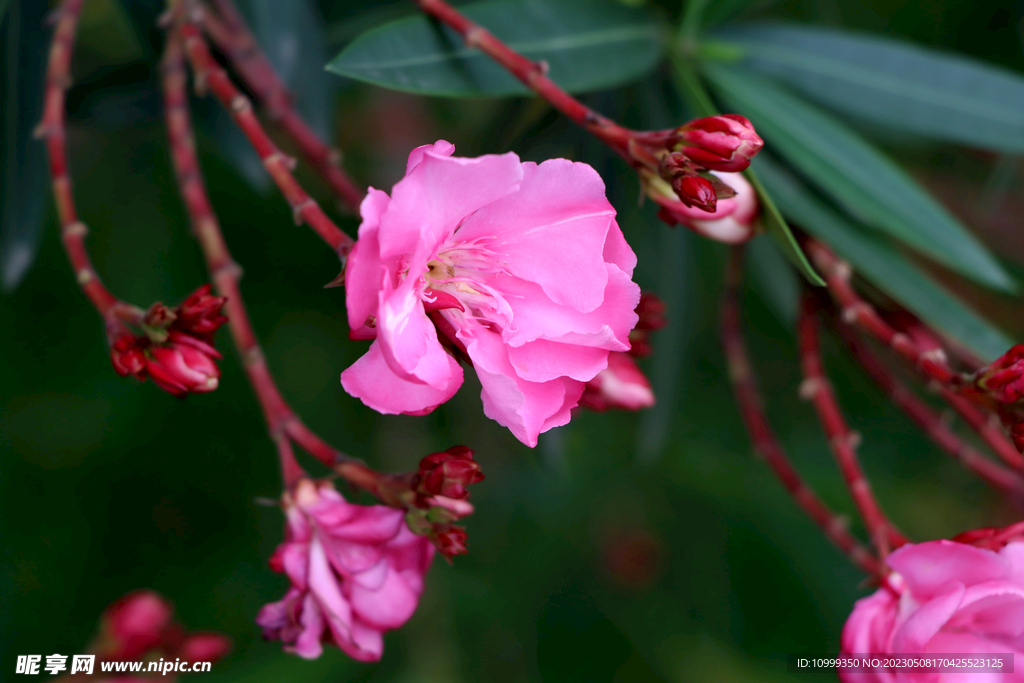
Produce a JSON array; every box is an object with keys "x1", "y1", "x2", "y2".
[{"x1": 111, "y1": 285, "x2": 227, "y2": 397}]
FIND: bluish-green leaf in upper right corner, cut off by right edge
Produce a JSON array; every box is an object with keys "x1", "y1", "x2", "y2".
[{"x1": 715, "y1": 24, "x2": 1024, "y2": 154}]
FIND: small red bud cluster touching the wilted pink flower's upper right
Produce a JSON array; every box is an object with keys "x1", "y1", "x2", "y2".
[{"x1": 406, "y1": 445, "x2": 483, "y2": 561}]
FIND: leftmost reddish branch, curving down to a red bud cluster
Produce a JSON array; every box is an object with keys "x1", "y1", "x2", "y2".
[{"x1": 35, "y1": 0, "x2": 142, "y2": 340}]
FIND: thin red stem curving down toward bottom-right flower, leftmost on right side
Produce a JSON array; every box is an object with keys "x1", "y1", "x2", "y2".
[{"x1": 721, "y1": 248, "x2": 880, "y2": 574}]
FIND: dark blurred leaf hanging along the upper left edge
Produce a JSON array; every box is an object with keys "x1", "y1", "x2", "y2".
[{"x1": 0, "y1": 0, "x2": 49, "y2": 292}]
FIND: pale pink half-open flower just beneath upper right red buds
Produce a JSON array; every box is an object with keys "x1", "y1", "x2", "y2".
[{"x1": 648, "y1": 171, "x2": 760, "y2": 244}]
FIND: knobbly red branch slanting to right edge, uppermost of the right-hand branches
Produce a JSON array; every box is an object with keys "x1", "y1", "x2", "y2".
[{"x1": 804, "y1": 240, "x2": 1024, "y2": 470}]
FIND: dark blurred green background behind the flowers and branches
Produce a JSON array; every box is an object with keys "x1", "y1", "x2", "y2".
[{"x1": 0, "y1": 0, "x2": 1024, "y2": 683}]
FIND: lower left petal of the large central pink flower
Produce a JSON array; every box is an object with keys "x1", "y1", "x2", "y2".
[{"x1": 341, "y1": 340, "x2": 463, "y2": 415}]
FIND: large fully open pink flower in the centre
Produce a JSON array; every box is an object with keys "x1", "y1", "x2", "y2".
[{"x1": 341, "y1": 140, "x2": 640, "y2": 446}]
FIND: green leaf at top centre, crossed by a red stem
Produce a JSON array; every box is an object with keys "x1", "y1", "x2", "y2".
[{"x1": 328, "y1": 0, "x2": 667, "y2": 97}]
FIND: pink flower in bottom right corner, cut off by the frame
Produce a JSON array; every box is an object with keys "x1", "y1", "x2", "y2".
[{"x1": 840, "y1": 541, "x2": 1024, "y2": 683}]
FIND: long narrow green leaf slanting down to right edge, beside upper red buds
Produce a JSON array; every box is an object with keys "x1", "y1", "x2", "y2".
[{"x1": 703, "y1": 63, "x2": 1017, "y2": 292}]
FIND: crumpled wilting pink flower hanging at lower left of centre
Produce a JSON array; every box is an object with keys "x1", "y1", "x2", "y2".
[{"x1": 256, "y1": 479, "x2": 434, "y2": 661}]
